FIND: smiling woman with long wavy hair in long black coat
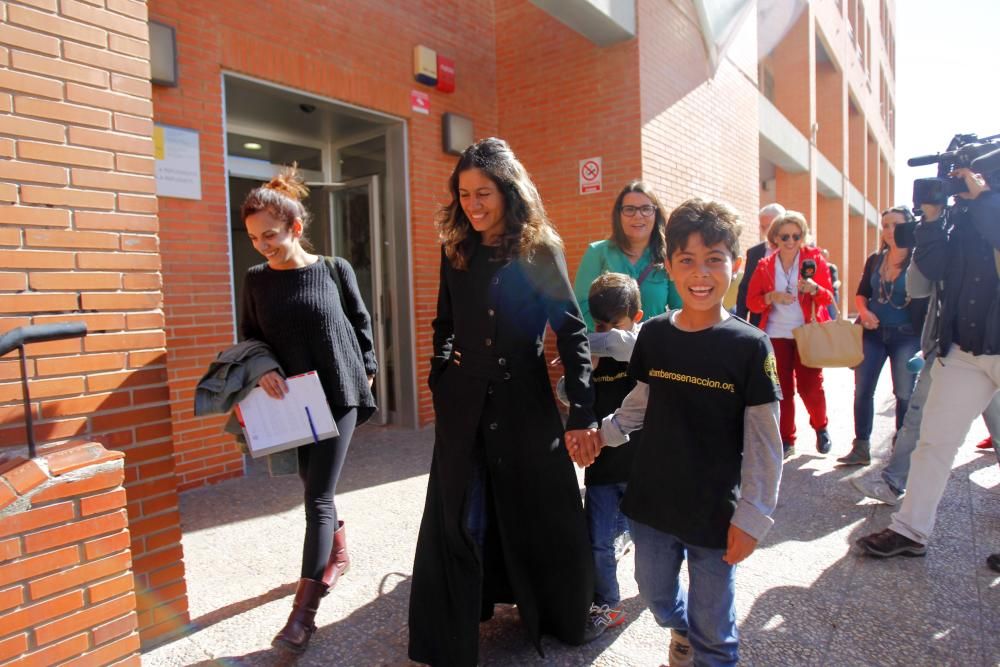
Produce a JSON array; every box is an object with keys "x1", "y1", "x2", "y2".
[{"x1": 409, "y1": 139, "x2": 596, "y2": 665}]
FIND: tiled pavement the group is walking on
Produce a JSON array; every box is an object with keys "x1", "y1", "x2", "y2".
[{"x1": 143, "y1": 370, "x2": 1000, "y2": 667}]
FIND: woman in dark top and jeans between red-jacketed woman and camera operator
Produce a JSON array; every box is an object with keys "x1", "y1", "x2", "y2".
[{"x1": 837, "y1": 206, "x2": 927, "y2": 465}]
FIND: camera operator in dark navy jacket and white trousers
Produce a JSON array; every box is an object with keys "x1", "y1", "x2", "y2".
[{"x1": 858, "y1": 168, "x2": 1000, "y2": 557}]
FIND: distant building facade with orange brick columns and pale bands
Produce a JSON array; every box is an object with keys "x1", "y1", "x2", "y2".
[{"x1": 758, "y1": 0, "x2": 907, "y2": 312}]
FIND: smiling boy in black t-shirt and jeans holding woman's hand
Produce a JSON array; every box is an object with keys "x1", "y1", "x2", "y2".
[{"x1": 567, "y1": 199, "x2": 781, "y2": 665}]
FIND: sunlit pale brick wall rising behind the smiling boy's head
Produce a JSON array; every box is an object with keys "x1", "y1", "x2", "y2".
[{"x1": 638, "y1": 0, "x2": 760, "y2": 240}]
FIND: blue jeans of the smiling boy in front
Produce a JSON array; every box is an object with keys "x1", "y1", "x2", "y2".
[{"x1": 631, "y1": 520, "x2": 739, "y2": 667}]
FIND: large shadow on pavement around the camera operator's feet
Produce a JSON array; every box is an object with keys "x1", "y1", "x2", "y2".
[{"x1": 740, "y1": 453, "x2": 997, "y2": 666}]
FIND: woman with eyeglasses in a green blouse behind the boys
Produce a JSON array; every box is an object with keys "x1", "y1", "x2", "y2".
[{"x1": 573, "y1": 181, "x2": 681, "y2": 331}]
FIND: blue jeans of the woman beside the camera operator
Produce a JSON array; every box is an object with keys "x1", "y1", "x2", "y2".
[{"x1": 854, "y1": 324, "x2": 920, "y2": 440}]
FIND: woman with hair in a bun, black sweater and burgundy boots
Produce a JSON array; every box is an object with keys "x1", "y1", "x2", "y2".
[{"x1": 240, "y1": 168, "x2": 377, "y2": 653}]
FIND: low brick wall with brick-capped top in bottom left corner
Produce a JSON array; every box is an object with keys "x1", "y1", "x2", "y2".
[{"x1": 0, "y1": 443, "x2": 139, "y2": 667}]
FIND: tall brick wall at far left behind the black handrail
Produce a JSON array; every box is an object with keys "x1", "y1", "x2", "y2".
[{"x1": 0, "y1": 0, "x2": 187, "y2": 648}]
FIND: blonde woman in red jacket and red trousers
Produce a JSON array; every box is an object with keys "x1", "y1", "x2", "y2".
[{"x1": 747, "y1": 211, "x2": 833, "y2": 458}]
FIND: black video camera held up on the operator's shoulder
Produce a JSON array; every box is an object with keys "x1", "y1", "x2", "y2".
[{"x1": 906, "y1": 134, "x2": 1000, "y2": 210}]
